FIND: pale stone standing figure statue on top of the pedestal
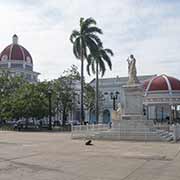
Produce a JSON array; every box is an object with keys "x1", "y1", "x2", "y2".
[{"x1": 127, "y1": 54, "x2": 139, "y2": 85}]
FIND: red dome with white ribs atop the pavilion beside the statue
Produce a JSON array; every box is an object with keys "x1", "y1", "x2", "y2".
[{"x1": 143, "y1": 75, "x2": 180, "y2": 92}]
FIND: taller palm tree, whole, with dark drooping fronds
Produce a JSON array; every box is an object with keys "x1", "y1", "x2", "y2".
[{"x1": 70, "y1": 18, "x2": 102, "y2": 124}]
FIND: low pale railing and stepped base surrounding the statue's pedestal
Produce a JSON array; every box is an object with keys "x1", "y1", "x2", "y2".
[{"x1": 71, "y1": 120, "x2": 176, "y2": 141}]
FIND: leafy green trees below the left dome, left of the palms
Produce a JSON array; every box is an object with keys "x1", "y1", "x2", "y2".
[{"x1": 0, "y1": 65, "x2": 80, "y2": 123}]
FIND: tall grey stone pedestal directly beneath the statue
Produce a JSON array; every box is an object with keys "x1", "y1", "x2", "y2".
[{"x1": 122, "y1": 84, "x2": 144, "y2": 120}]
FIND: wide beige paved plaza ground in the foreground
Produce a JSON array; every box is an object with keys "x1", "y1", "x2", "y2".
[{"x1": 0, "y1": 132, "x2": 180, "y2": 180}]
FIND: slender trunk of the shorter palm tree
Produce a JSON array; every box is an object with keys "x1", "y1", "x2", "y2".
[{"x1": 95, "y1": 62, "x2": 99, "y2": 124}]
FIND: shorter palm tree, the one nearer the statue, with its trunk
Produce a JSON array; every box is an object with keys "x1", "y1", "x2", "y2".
[{"x1": 87, "y1": 47, "x2": 114, "y2": 123}]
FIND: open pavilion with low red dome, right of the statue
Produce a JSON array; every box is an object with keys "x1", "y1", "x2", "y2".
[{"x1": 143, "y1": 74, "x2": 180, "y2": 123}]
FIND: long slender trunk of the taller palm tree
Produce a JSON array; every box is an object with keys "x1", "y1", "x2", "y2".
[{"x1": 80, "y1": 45, "x2": 84, "y2": 124}]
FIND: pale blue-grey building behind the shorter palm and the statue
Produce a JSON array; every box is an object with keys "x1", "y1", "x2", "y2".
[{"x1": 89, "y1": 75, "x2": 156, "y2": 123}]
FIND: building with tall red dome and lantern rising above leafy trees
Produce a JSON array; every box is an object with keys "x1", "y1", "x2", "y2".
[{"x1": 0, "y1": 34, "x2": 39, "y2": 83}]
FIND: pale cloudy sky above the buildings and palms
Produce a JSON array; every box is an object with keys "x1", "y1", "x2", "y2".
[{"x1": 0, "y1": 0, "x2": 180, "y2": 81}]
